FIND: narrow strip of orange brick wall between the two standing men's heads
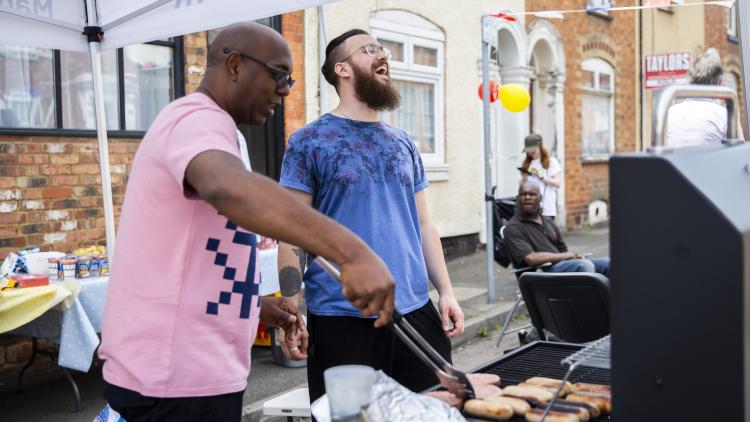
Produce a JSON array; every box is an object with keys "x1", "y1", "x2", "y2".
[{"x1": 281, "y1": 10, "x2": 306, "y2": 139}]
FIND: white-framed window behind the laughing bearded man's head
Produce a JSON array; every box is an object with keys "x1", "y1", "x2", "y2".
[{"x1": 370, "y1": 10, "x2": 445, "y2": 168}]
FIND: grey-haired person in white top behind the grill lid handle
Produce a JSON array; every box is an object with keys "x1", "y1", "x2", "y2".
[{"x1": 667, "y1": 48, "x2": 743, "y2": 148}]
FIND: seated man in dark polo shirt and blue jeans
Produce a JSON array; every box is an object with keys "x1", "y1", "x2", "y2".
[{"x1": 504, "y1": 180, "x2": 609, "y2": 277}]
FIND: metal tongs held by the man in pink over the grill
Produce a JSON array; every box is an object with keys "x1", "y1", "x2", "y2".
[{"x1": 315, "y1": 256, "x2": 476, "y2": 400}]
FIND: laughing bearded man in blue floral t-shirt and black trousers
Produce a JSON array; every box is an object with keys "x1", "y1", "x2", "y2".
[{"x1": 279, "y1": 29, "x2": 464, "y2": 400}]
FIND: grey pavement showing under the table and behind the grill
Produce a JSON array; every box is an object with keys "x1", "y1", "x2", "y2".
[{"x1": 0, "y1": 228, "x2": 609, "y2": 422}]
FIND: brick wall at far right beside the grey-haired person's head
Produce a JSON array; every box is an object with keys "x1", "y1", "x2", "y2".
[{"x1": 705, "y1": 6, "x2": 748, "y2": 137}]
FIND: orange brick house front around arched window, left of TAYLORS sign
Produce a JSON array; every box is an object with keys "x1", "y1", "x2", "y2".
[{"x1": 526, "y1": 0, "x2": 638, "y2": 227}]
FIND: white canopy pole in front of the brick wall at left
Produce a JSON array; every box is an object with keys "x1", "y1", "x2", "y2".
[{"x1": 84, "y1": 0, "x2": 115, "y2": 267}]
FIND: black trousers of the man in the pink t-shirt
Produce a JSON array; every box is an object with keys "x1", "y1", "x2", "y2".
[{"x1": 104, "y1": 381, "x2": 245, "y2": 422}]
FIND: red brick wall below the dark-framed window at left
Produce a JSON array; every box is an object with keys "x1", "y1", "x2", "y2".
[{"x1": 0, "y1": 136, "x2": 138, "y2": 258}]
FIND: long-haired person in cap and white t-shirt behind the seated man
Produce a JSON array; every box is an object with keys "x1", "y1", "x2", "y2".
[{"x1": 521, "y1": 133, "x2": 563, "y2": 221}]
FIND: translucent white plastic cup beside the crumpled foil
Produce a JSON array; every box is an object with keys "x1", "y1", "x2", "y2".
[{"x1": 323, "y1": 365, "x2": 375, "y2": 422}]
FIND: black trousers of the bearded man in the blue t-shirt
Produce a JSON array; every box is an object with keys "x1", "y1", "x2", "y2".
[{"x1": 307, "y1": 301, "x2": 452, "y2": 403}]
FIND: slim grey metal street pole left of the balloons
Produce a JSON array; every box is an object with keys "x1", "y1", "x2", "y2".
[{"x1": 481, "y1": 16, "x2": 495, "y2": 303}]
